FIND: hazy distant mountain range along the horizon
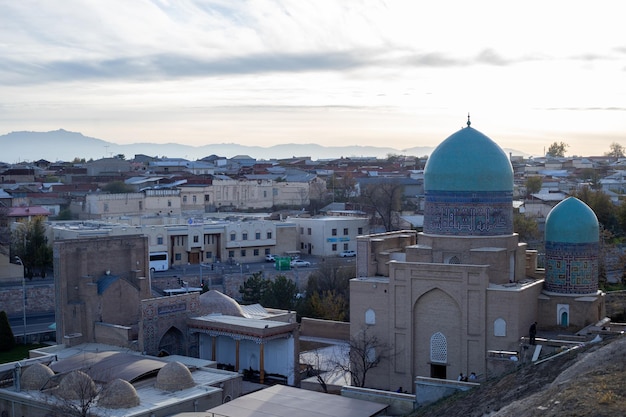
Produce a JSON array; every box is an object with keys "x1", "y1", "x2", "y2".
[{"x1": 0, "y1": 129, "x2": 523, "y2": 163}]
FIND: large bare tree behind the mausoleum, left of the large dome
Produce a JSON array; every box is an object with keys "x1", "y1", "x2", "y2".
[{"x1": 361, "y1": 181, "x2": 404, "y2": 232}]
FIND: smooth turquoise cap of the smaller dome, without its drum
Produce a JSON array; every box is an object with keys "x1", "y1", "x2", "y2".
[{"x1": 545, "y1": 197, "x2": 600, "y2": 243}]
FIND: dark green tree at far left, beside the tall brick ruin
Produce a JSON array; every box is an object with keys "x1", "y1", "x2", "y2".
[{"x1": 11, "y1": 216, "x2": 52, "y2": 278}]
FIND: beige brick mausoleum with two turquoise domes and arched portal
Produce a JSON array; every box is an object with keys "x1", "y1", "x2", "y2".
[{"x1": 350, "y1": 120, "x2": 604, "y2": 390}]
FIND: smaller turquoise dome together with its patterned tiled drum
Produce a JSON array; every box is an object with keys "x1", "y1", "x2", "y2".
[{"x1": 544, "y1": 197, "x2": 600, "y2": 294}]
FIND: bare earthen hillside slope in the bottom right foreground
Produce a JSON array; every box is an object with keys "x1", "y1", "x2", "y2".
[{"x1": 411, "y1": 335, "x2": 626, "y2": 417}]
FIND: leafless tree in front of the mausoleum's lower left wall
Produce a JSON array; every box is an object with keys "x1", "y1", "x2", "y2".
[{"x1": 334, "y1": 326, "x2": 393, "y2": 387}]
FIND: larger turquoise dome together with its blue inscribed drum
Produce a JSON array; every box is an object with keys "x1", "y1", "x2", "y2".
[{"x1": 424, "y1": 121, "x2": 513, "y2": 236}]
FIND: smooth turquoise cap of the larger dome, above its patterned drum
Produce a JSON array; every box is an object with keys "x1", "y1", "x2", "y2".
[{"x1": 424, "y1": 126, "x2": 513, "y2": 191}]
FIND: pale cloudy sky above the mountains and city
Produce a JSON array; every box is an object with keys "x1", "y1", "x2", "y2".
[{"x1": 0, "y1": 0, "x2": 626, "y2": 156}]
